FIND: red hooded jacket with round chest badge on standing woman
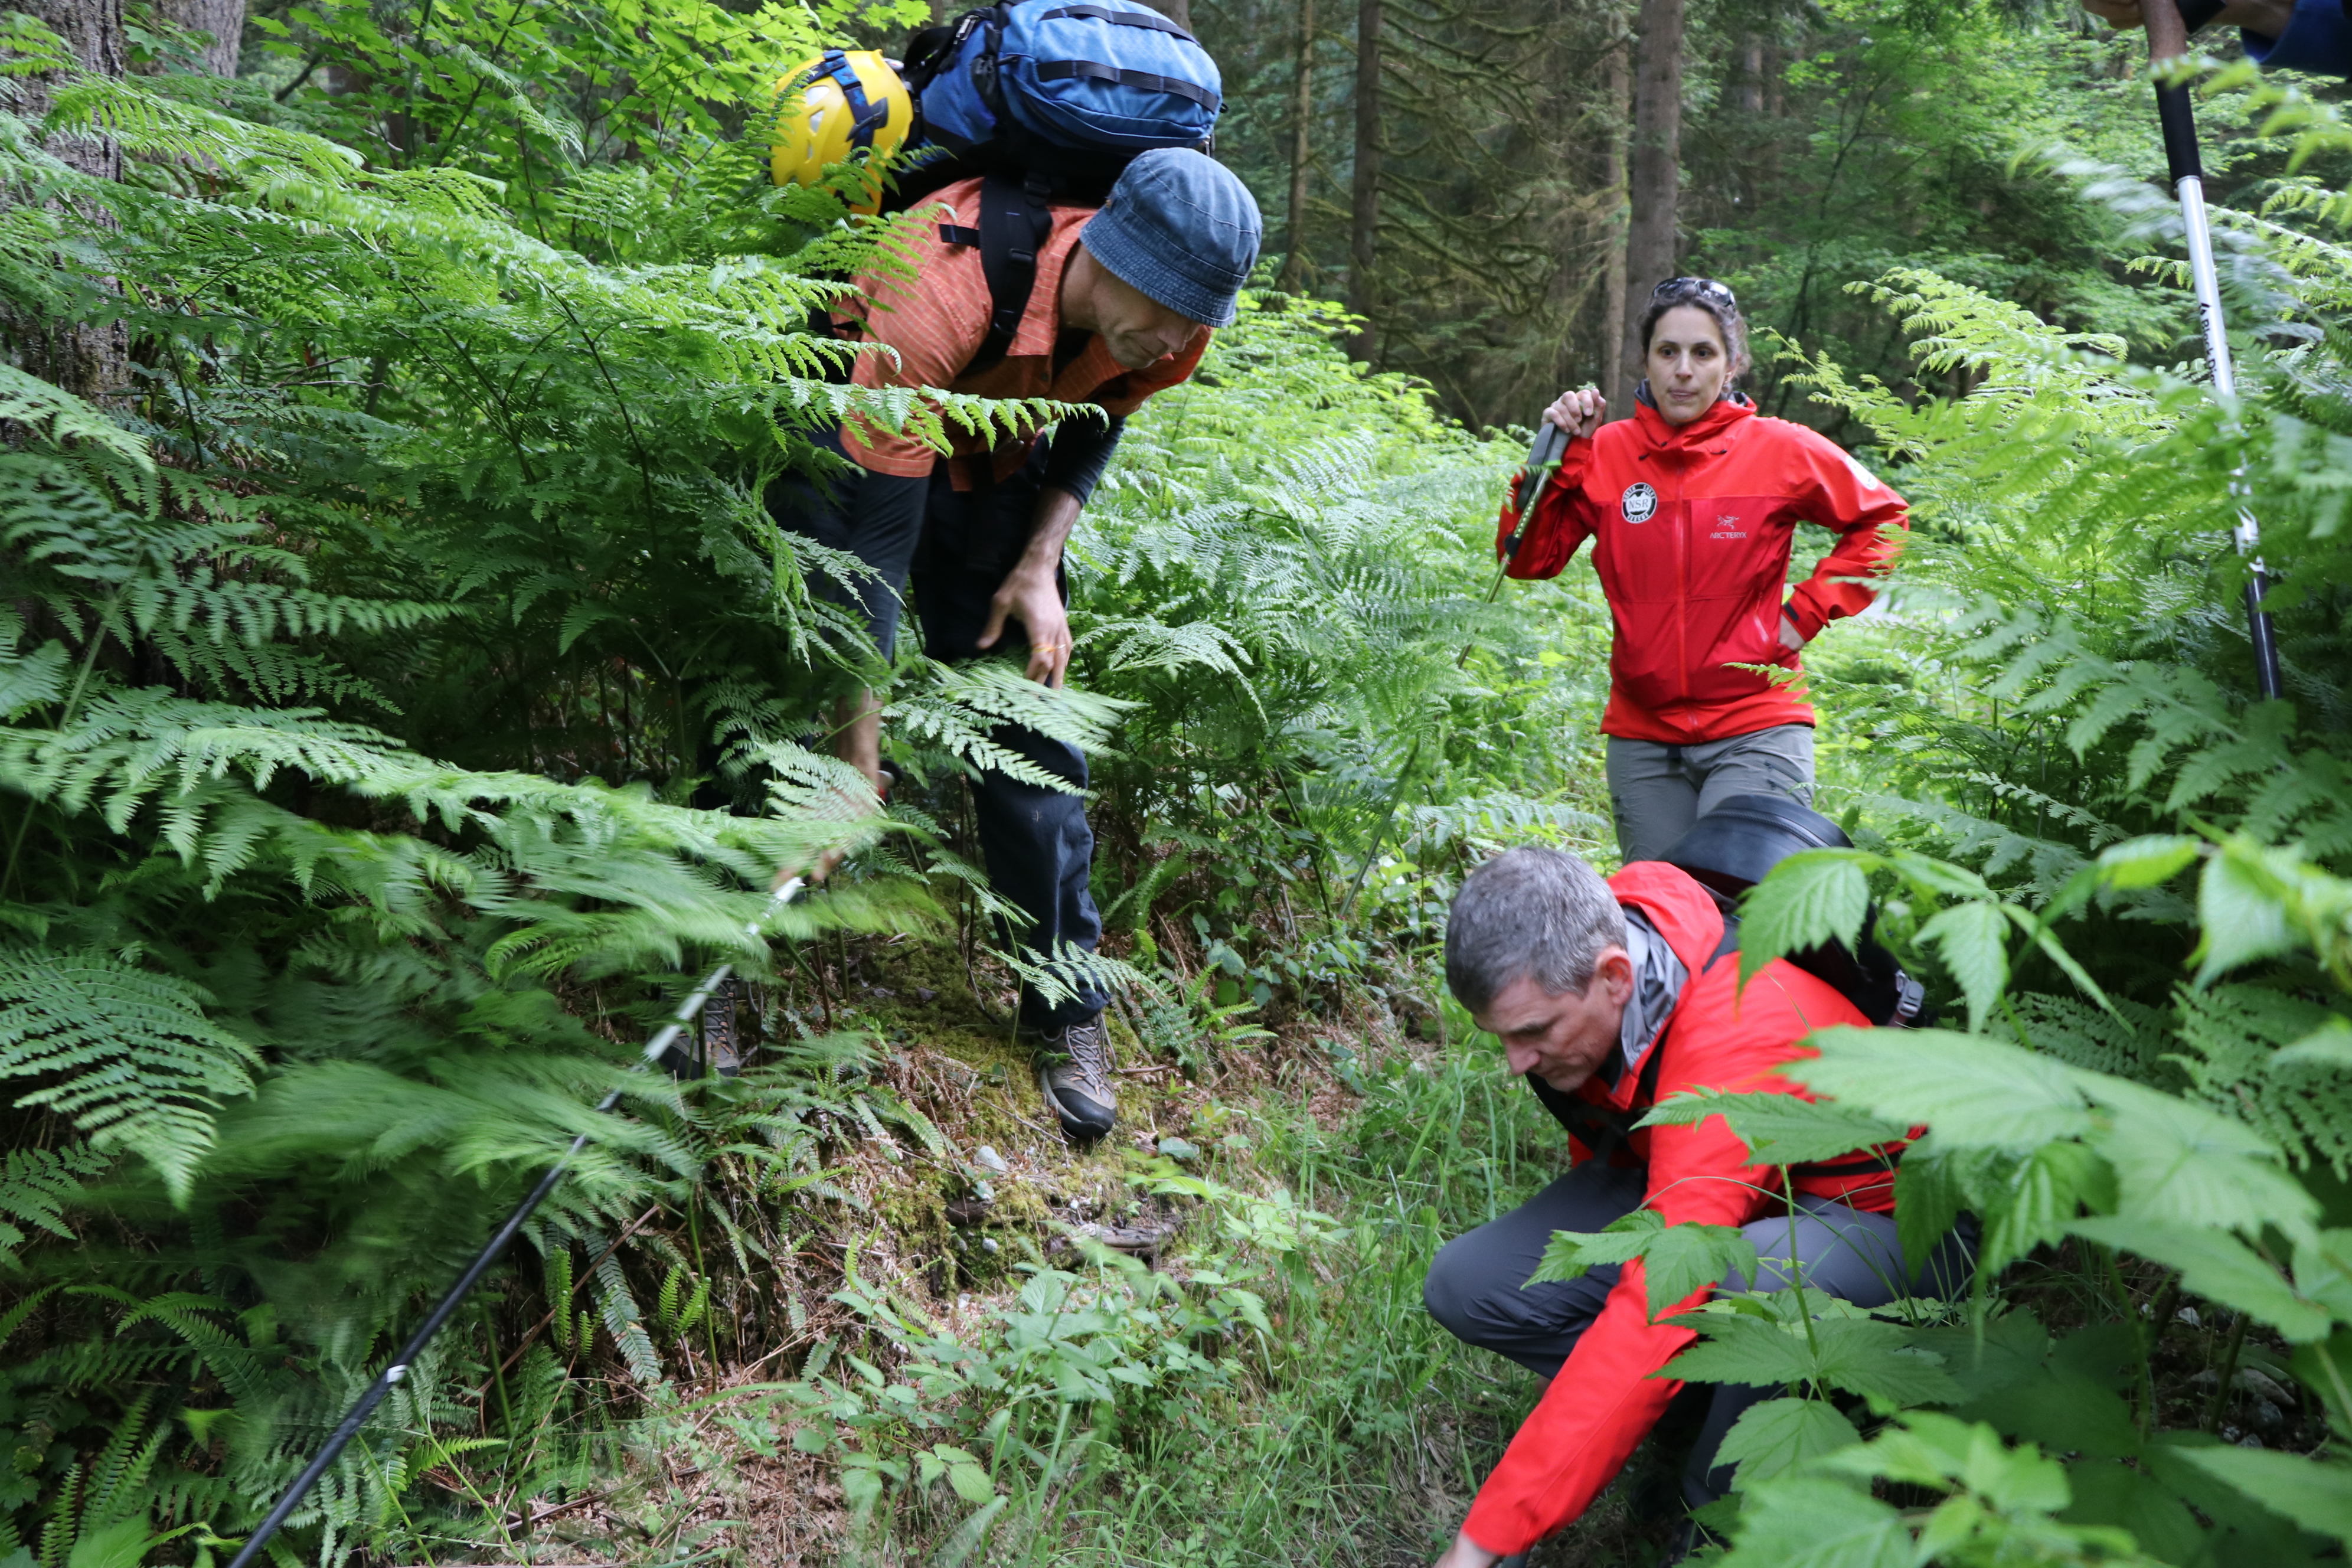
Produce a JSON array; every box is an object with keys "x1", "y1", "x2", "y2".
[{"x1": 1496, "y1": 400, "x2": 1910, "y2": 745}]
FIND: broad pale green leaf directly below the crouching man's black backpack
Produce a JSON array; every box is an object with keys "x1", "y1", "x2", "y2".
[{"x1": 1783, "y1": 1025, "x2": 2091, "y2": 1154}]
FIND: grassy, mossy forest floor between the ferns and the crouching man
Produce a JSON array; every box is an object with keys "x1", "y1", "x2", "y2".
[{"x1": 458, "y1": 907, "x2": 1670, "y2": 1568}]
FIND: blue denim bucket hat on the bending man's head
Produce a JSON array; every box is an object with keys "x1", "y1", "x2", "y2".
[{"x1": 1077, "y1": 148, "x2": 1260, "y2": 326}]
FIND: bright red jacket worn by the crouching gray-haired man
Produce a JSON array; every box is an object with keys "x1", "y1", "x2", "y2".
[{"x1": 1463, "y1": 860, "x2": 1900, "y2": 1554}]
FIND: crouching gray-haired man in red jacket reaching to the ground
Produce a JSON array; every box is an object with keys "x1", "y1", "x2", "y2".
[{"x1": 1423, "y1": 849, "x2": 1969, "y2": 1568}]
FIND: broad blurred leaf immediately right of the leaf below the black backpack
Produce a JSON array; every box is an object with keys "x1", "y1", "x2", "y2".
[{"x1": 2075, "y1": 1072, "x2": 2319, "y2": 1237}]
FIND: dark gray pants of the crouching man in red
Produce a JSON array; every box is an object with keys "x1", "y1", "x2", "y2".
[{"x1": 1420, "y1": 1161, "x2": 1974, "y2": 1507}]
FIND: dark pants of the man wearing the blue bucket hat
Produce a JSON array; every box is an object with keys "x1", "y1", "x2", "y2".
[{"x1": 769, "y1": 442, "x2": 1108, "y2": 1030}]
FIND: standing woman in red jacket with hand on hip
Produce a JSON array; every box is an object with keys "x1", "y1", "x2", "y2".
[{"x1": 1498, "y1": 277, "x2": 1910, "y2": 863}]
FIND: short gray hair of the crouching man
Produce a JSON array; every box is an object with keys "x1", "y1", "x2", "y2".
[{"x1": 1446, "y1": 847, "x2": 1625, "y2": 1013}]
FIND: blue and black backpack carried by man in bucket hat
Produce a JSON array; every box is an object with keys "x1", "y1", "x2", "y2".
[{"x1": 889, "y1": 0, "x2": 1226, "y2": 369}]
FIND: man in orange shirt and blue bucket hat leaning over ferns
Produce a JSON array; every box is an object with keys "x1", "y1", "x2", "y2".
[{"x1": 769, "y1": 148, "x2": 1260, "y2": 1140}]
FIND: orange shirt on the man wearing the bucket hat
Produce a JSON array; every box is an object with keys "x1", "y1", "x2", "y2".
[{"x1": 835, "y1": 179, "x2": 1209, "y2": 489}]
